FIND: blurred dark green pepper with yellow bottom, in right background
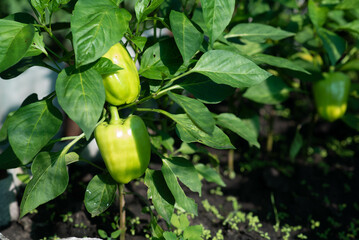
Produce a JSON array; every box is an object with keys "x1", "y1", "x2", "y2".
[{"x1": 313, "y1": 72, "x2": 350, "y2": 122}]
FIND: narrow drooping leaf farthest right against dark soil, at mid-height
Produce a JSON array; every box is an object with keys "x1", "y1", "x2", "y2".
[{"x1": 216, "y1": 113, "x2": 260, "y2": 148}]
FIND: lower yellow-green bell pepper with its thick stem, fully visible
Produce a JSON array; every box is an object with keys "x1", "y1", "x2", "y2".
[{"x1": 95, "y1": 106, "x2": 151, "y2": 184}]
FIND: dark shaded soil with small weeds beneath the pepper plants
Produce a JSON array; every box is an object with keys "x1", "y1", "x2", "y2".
[{"x1": 0, "y1": 112, "x2": 359, "y2": 240}]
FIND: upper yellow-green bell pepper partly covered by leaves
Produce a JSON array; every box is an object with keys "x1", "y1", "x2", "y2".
[{"x1": 103, "y1": 43, "x2": 141, "y2": 106}]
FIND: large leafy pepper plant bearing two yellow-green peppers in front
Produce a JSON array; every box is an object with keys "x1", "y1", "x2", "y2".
[{"x1": 0, "y1": 0, "x2": 355, "y2": 239}]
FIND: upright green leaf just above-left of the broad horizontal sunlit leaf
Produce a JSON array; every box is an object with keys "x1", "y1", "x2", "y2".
[{"x1": 170, "y1": 11, "x2": 203, "y2": 64}]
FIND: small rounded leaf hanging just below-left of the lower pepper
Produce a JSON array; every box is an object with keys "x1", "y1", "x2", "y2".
[{"x1": 84, "y1": 173, "x2": 117, "y2": 217}]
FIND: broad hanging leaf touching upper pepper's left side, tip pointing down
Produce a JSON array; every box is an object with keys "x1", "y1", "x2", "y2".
[{"x1": 56, "y1": 67, "x2": 105, "y2": 139}]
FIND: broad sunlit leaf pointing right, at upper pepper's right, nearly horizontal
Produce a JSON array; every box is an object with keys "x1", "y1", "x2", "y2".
[{"x1": 191, "y1": 50, "x2": 271, "y2": 88}]
